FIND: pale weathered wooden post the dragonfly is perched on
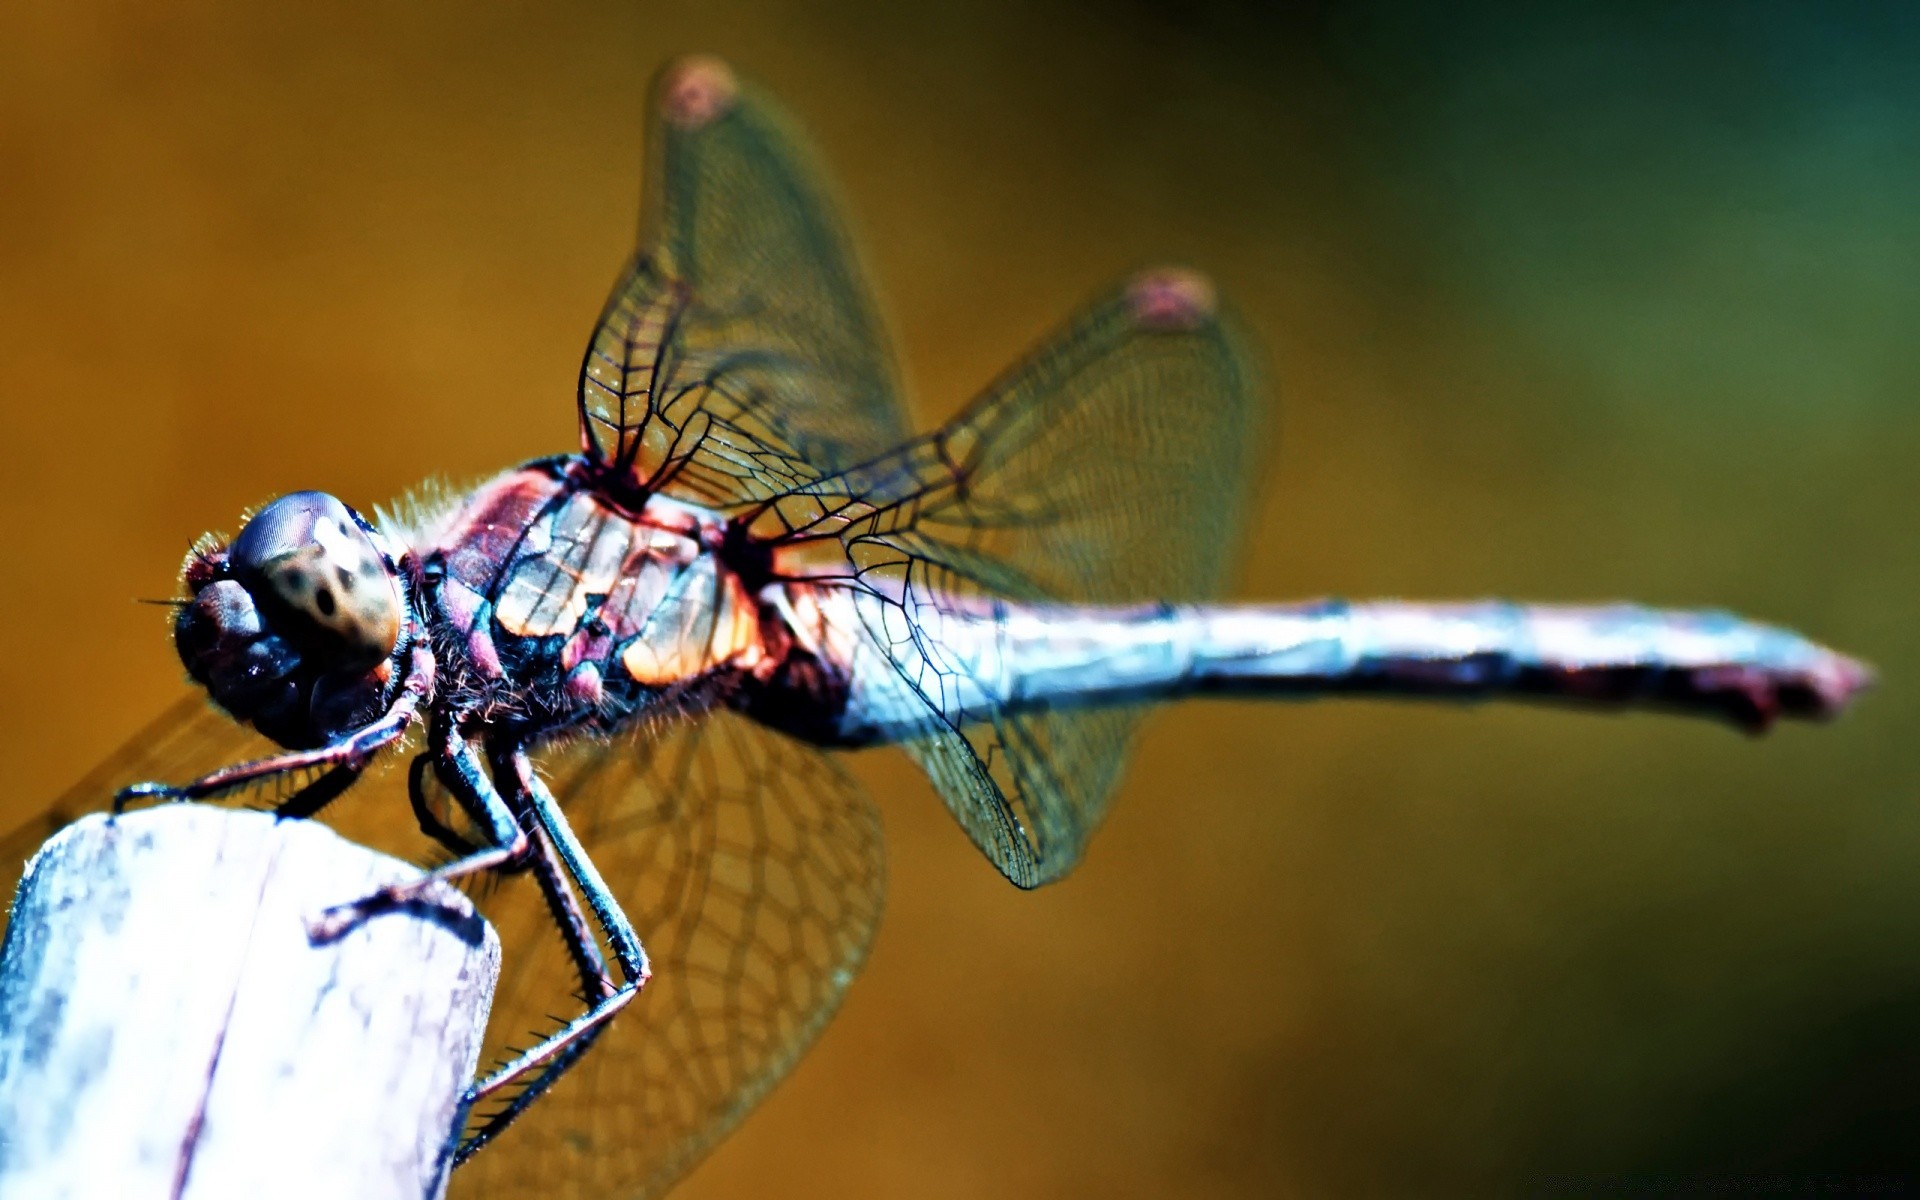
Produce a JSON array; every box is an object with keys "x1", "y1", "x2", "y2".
[{"x1": 0, "y1": 804, "x2": 499, "y2": 1200}]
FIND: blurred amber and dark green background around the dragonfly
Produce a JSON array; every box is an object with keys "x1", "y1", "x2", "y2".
[{"x1": 0, "y1": 0, "x2": 1920, "y2": 1198}]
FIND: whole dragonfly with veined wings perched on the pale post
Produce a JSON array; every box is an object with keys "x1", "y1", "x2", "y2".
[{"x1": 3, "y1": 58, "x2": 1870, "y2": 1196}]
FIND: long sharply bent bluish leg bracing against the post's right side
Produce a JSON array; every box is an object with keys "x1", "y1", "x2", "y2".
[{"x1": 453, "y1": 747, "x2": 651, "y2": 1164}]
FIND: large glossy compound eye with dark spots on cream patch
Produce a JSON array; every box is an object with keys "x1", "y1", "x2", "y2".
[{"x1": 228, "y1": 492, "x2": 401, "y2": 666}]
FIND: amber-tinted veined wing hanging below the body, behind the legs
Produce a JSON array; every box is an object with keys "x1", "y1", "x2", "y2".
[{"x1": 451, "y1": 712, "x2": 883, "y2": 1200}]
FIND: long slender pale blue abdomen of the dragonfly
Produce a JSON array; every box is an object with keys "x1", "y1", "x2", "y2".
[{"x1": 839, "y1": 597, "x2": 1872, "y2": 741}]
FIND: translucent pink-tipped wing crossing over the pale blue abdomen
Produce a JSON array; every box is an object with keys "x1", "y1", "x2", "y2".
[{"x1": 756, "y1": 271, "x2": 1263, "y2": 887}]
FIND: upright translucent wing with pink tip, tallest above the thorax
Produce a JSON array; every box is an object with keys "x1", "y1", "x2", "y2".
[{"x1": 580, "y1": 60, "x2": 908, "y2": 509}]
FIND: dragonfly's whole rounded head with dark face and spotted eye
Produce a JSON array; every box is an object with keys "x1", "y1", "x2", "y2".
[{"x1": 173, "y1": 492, "x2": 407, "y2": 749}]
